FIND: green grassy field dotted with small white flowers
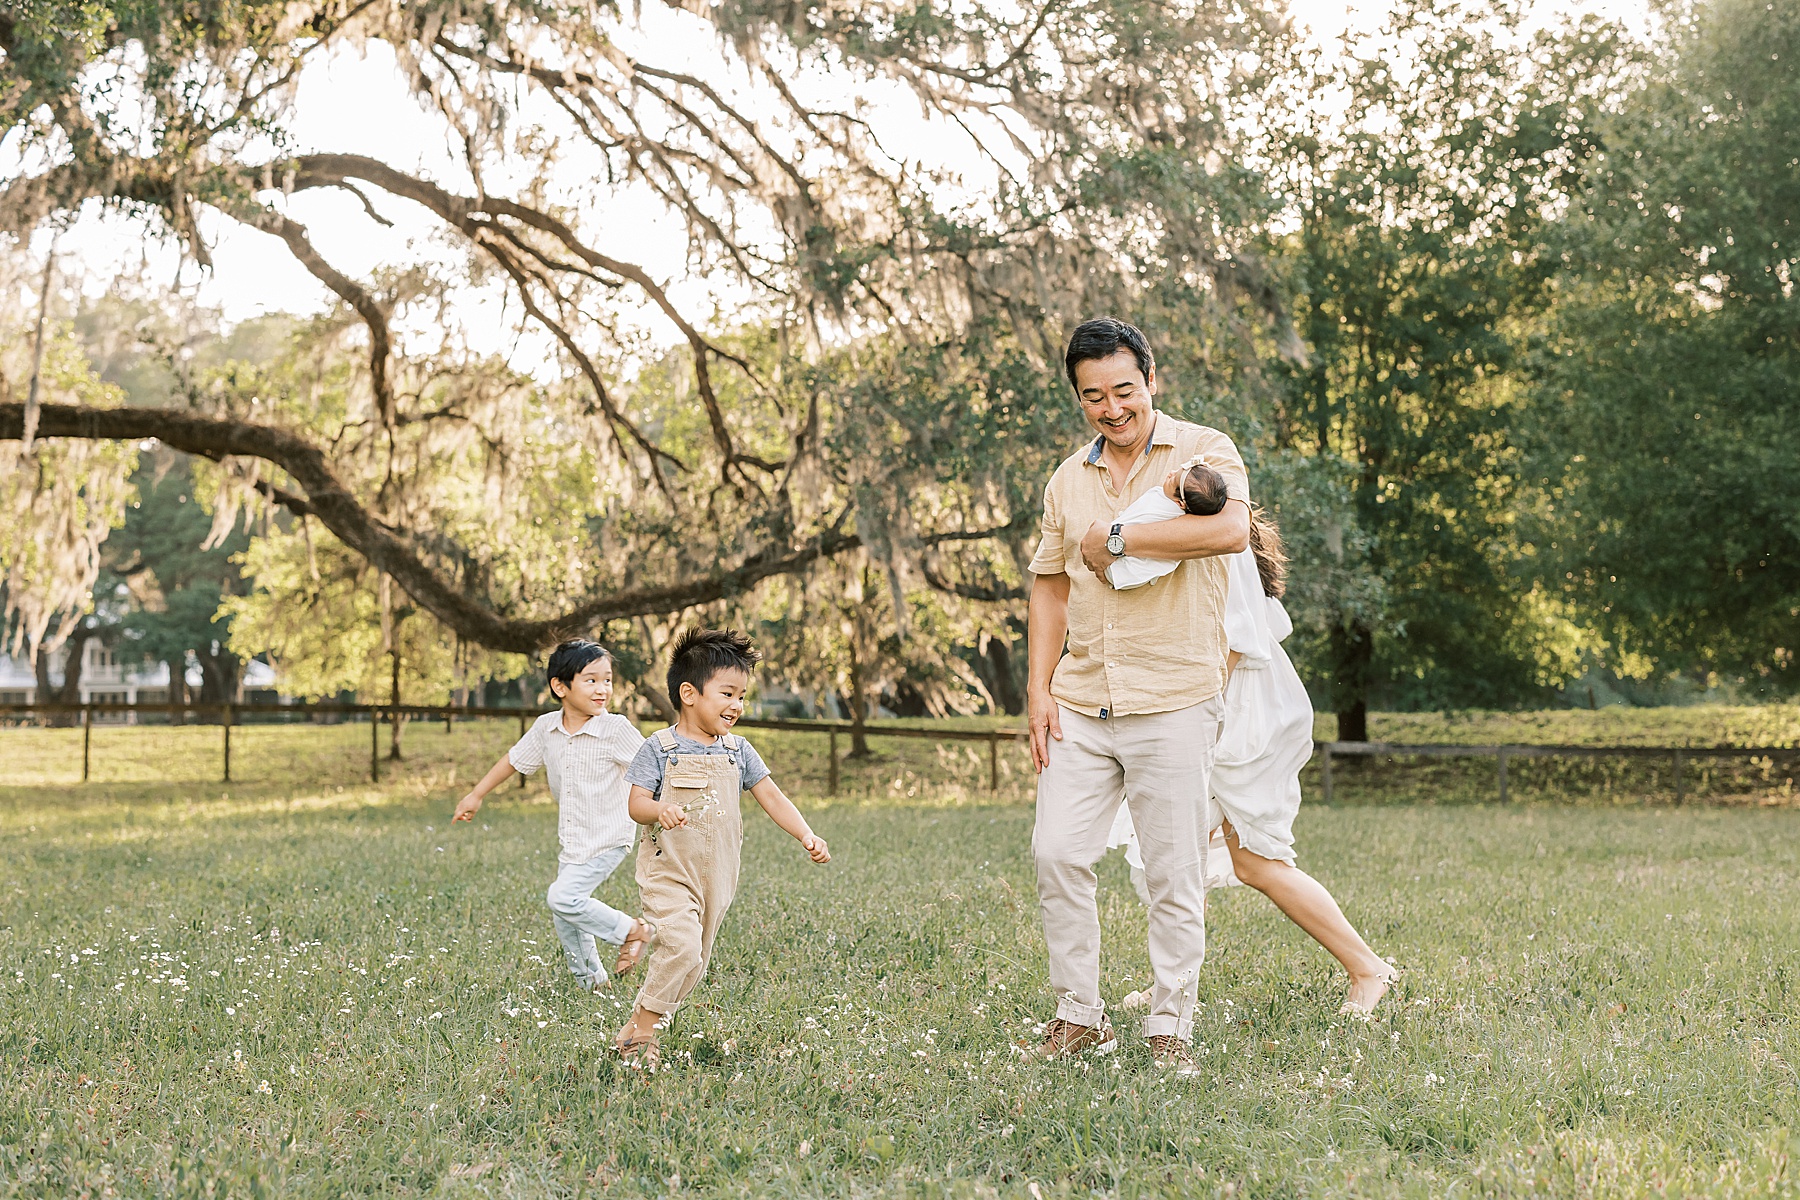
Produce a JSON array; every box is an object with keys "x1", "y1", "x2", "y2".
[{"x1": 0, "y1": 725, "x2": 1800, "y2": 1196}]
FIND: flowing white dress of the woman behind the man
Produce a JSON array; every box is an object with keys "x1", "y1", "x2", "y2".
[{"x1": 1107, "y1": 551, "x2": 1312, "y2": 887}]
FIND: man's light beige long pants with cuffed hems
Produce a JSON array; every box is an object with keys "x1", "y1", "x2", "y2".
[{"x1": 1031, "y1": 698, "x2": 1220, "y2": 1042}]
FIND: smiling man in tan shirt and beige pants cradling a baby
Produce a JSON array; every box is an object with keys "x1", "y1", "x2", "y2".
[{"x1": 1030, "y1": 318, "x2": 1249, "y2": 1074}]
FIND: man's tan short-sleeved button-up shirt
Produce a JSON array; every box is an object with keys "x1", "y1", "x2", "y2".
[{"x1": 1031, "y1": 412, "x2": 1249, "y2": 716}]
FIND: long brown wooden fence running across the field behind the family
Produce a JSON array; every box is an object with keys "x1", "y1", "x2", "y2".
[{"x1": 0, "y1": 700, "x2": 1800, "y2": 802}]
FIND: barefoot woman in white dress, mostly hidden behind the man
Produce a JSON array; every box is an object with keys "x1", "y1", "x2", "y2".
[{"x1": 1109, "y1": 513, "x2": 1397, "y2": 1016}]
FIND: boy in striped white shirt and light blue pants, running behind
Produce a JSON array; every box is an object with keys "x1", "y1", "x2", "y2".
[{"x1": 454, "y1": 639, "x2": 652, "y2": 990}]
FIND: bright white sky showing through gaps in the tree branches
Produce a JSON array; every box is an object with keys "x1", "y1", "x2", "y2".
[{"x1": 32, "y1": 0, "x2": 1645, "y2": 356}]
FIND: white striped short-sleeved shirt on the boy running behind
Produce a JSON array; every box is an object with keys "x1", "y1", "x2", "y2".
[{"x1": 506, "y1": 711, "x2": 644, "y2": 862}]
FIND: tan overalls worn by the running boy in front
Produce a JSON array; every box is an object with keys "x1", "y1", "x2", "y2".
[{"x1": 637, "y1": 729, "x2": 743, "y2": 1015}]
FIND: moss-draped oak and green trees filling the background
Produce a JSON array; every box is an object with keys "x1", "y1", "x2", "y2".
[{"x1": 0, "y1": 0, "x2": 1800, "y2": 738}]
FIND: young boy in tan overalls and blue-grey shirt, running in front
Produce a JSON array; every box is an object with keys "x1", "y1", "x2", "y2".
[{"x1": 616, "y1": 630, "x2": 832, "y2": 1070}]
